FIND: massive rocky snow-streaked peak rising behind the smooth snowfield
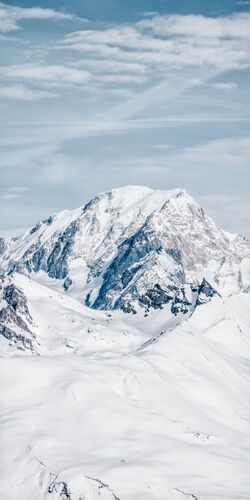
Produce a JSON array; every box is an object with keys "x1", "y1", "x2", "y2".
[{"x1": 0, "y1": 186, "x2": 250, "y2": 314}]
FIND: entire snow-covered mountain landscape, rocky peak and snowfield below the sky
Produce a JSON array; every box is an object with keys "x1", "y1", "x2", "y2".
[{"x1": 0, "y1": 186, "x2": 250, "y2": 500}]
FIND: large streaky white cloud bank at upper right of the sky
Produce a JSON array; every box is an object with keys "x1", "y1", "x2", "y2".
[{"x1": 63, "y1": 14, "x2": 250, "y2": 71}]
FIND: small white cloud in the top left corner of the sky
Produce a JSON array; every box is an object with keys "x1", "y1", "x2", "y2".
[{"x1": 0, "y1": 2, "x2": 74, "y2": 33}]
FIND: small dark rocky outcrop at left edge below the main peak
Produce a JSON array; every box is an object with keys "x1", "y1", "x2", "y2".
[{"x1": 0, "y1": 274, "x2": 36, "y2": 351}]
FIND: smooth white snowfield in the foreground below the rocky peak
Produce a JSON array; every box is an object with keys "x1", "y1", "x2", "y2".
[{"x1": 0, "y1": 274, "x2": 250, "y2": 500}]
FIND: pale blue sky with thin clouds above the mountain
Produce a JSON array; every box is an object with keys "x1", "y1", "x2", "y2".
[{"x1": 0, "y1": 0, "x2": 250, "y2": 236}]
